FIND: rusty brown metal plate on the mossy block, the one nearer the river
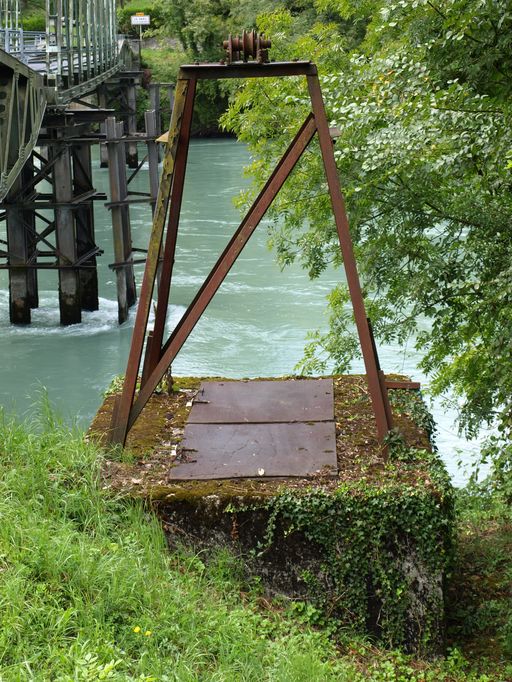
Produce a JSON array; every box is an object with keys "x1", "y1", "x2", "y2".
[{"x1": 188, "y1": 379, "x2": 334, "y2": 424}]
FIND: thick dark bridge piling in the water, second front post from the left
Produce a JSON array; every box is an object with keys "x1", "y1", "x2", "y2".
[{"x1": 51, "y1": 141, "x2": 82, "y2": 324}]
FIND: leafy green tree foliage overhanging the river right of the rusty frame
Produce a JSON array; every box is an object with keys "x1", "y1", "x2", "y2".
[{"x1": 223, "y1": 0, "x2": 512, "y2": 467}]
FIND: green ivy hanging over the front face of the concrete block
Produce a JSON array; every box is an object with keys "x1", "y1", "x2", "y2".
[{"x1": 255, "y1": 464, "x2": 454, "y2": 652}]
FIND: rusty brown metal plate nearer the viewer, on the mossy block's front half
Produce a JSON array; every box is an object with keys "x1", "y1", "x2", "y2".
[{"x1": 169, "y1": 422, "x2": 337, "y2": 480}]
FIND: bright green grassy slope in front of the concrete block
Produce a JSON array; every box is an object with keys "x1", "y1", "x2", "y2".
[{"x1": 0, "y1": 402, "x2": 512, "y2": 682}]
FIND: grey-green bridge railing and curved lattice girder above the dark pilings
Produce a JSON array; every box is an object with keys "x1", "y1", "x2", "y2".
[{"x1": 0, "y1": 0, "x2": 131, "y2": 200}]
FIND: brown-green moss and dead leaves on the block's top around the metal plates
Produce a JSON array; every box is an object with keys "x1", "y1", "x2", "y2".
[{"x1": 89, "y1": 375, "x2": 433, "y2": 499}]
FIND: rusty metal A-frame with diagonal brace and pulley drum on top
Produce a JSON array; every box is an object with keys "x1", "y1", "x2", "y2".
[{"x1": 109, "y1": 33, "x2": 393, "y2": 449}]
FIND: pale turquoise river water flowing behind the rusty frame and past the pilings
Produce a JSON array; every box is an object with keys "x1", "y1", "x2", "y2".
[{"x1": 0, "y1": 140, "x2": 484, "y2": 485}]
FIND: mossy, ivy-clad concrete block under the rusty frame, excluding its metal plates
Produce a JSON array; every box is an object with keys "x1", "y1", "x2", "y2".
[{"x1": 91, "y1": 376, "x2": 451, "y2": 653}]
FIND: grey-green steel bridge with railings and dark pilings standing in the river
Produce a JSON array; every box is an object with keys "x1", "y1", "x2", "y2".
[{"x1": 0, "y1": 0, "x2": 168, "y2": 324}]
